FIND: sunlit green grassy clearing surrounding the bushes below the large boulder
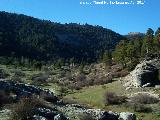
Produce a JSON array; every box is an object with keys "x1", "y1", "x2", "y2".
[{"x1": 65, "y1": 79, "x2": 160, "y2": 120}]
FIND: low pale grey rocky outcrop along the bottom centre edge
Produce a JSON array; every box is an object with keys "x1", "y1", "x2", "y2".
[{"x1": 58, "y1": 104, "x2": 136, "y2": 120}]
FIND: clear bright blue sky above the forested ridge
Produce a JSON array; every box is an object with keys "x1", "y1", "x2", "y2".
[{"x1": 0, "y1": 0, "x2": 160, "y2": 34}]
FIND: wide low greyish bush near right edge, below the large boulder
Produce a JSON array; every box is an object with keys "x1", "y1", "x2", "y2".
[{"x1": 131, "y1": 93, "x2": 159, "y2": 104}]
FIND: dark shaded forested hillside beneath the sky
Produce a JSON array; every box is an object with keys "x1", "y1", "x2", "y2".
[{"x1": 0, "y1": 12, "x2": 125, "y2": 64}]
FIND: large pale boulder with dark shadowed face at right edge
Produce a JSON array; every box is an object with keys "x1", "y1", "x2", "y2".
[{"x1": 124, "y1": 59, "x2": 160, "y2": 87}]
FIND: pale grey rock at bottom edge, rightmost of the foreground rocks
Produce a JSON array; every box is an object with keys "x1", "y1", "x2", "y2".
[{"x1": 119, "y1": 112, "x2": 136, "y2": 120}]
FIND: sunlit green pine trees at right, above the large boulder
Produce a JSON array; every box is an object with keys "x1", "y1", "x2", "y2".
[{"x1": 114, "y1": 28, "x2": 160, "y2": 70}]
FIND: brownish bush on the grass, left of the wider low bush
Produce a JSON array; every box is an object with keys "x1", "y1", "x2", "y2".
[{"x1": 104, "y1": 92, "x2": 127, "y2": 105}]
